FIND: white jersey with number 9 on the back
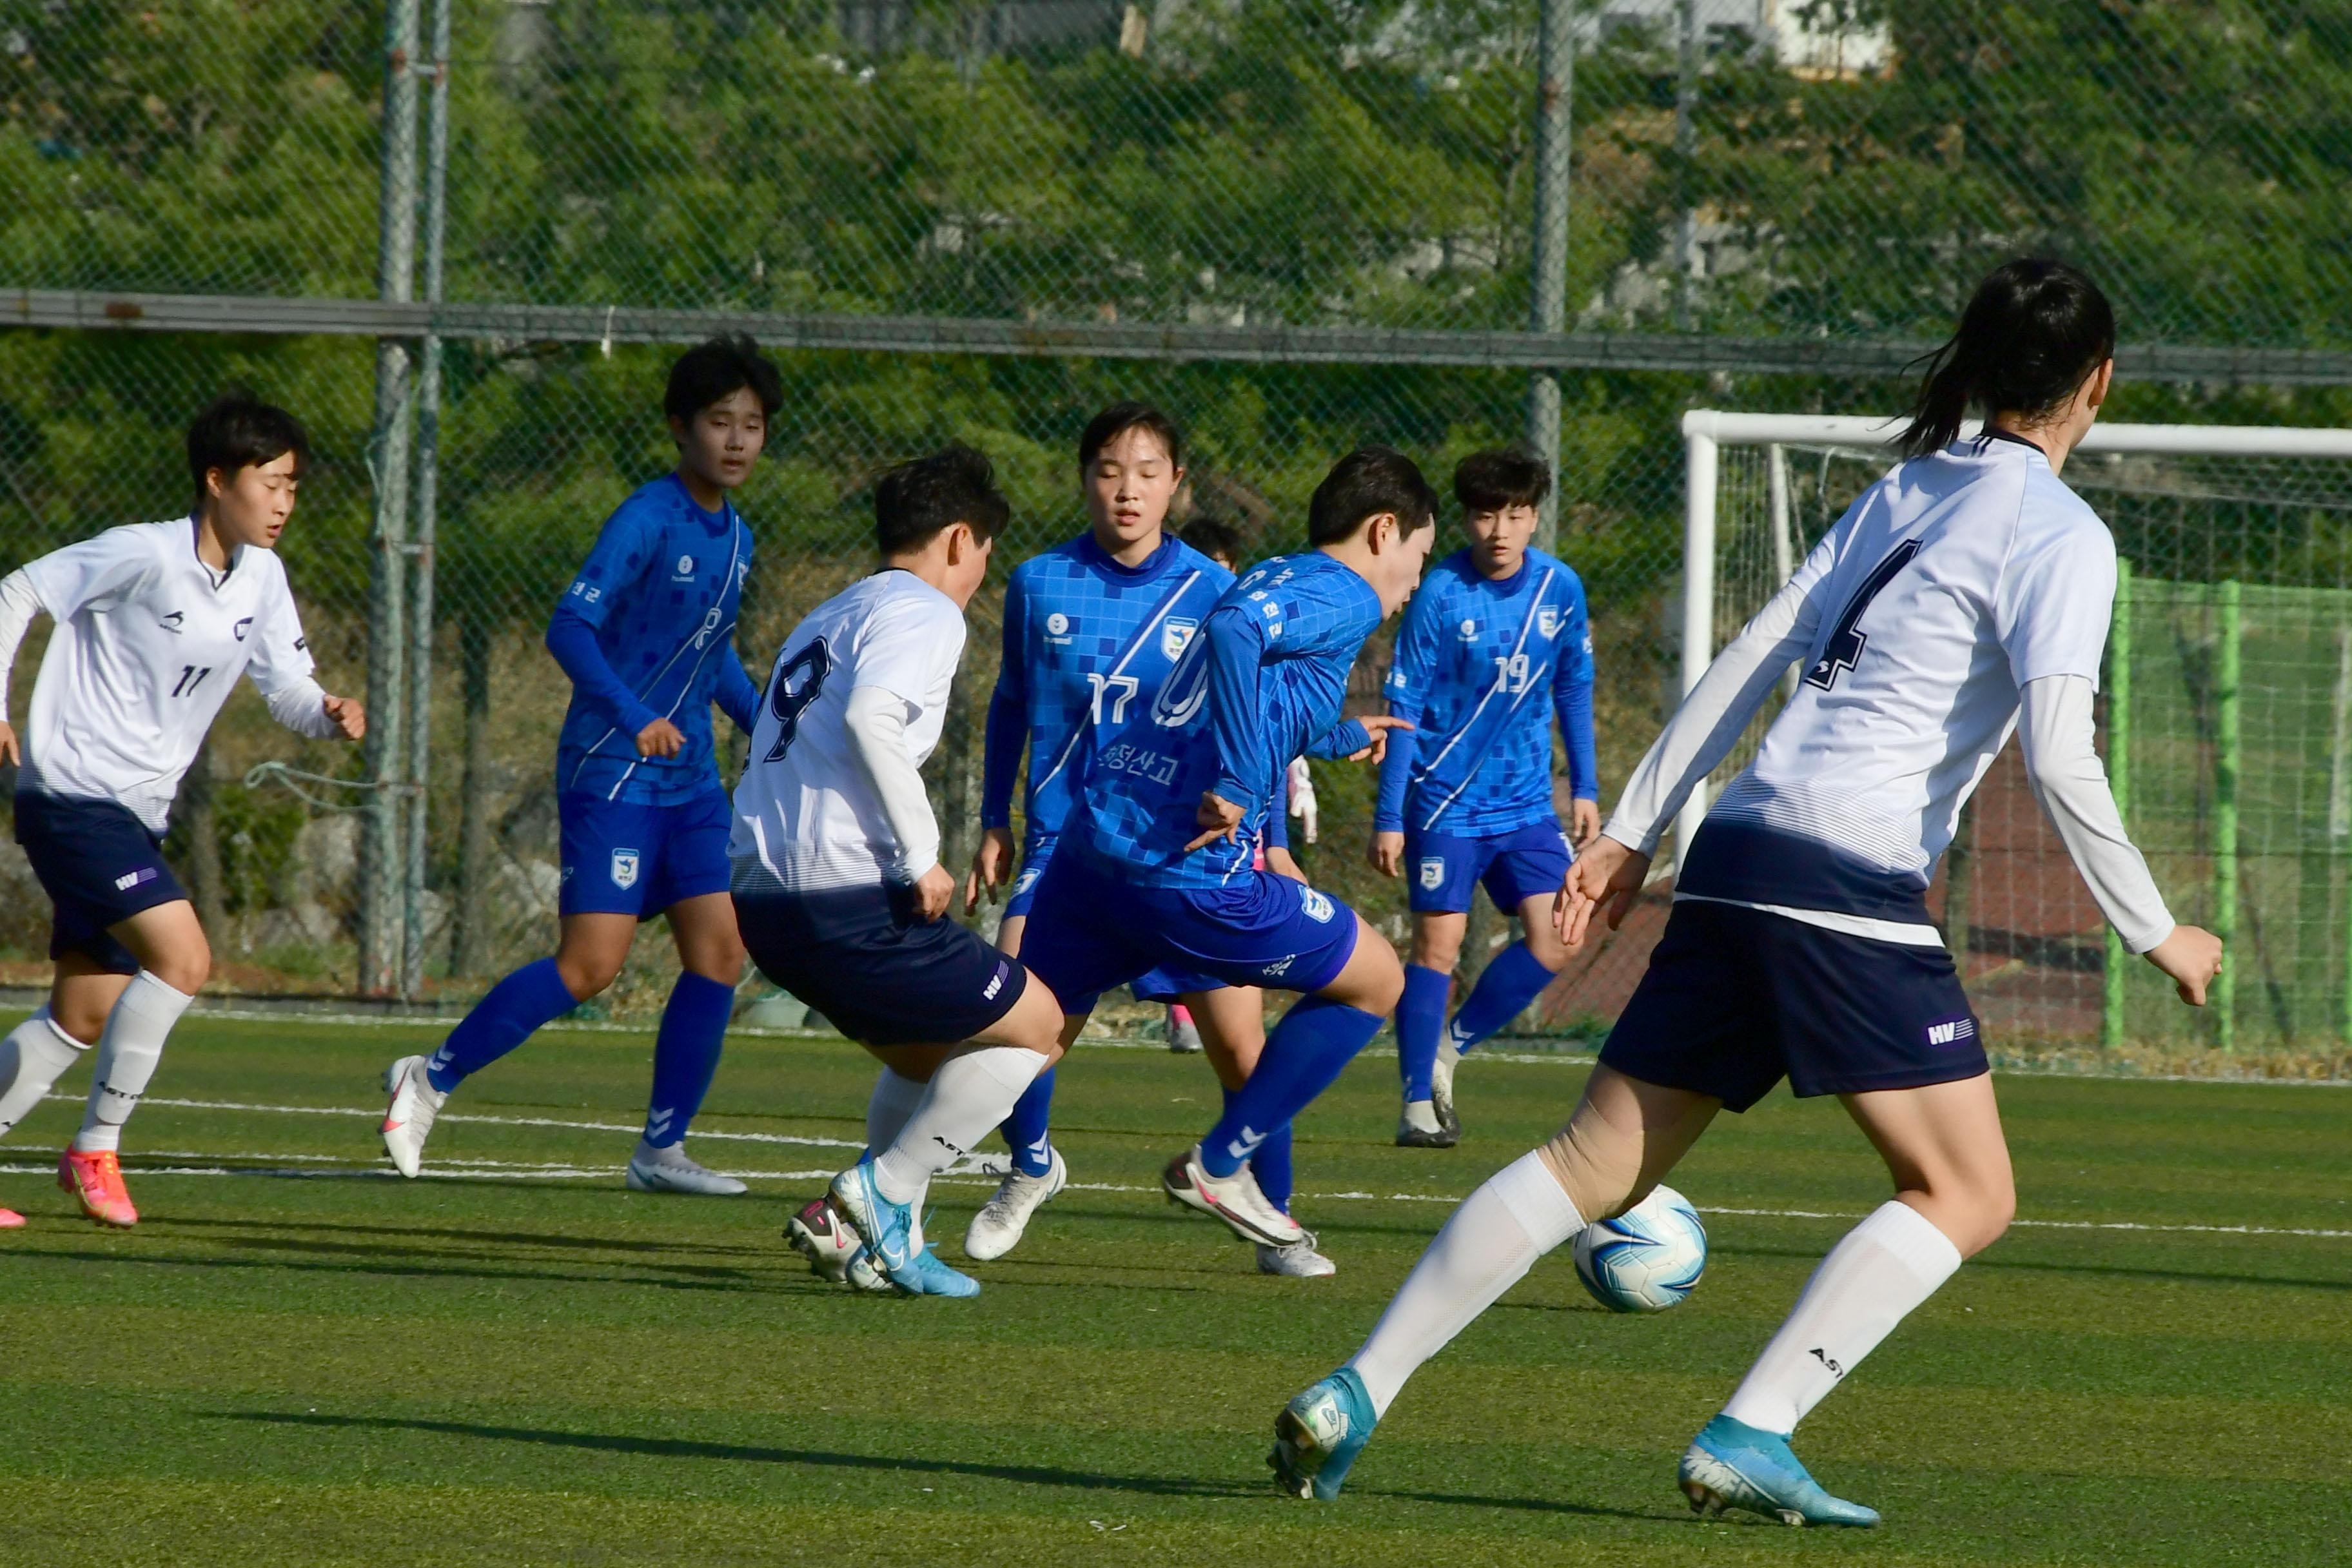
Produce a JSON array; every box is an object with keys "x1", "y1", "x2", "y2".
[{"x1": 727, "y1": 571, "x2": 965, "y2": 894}]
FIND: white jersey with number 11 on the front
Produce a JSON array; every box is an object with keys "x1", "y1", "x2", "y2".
[{"x1": 10, "y1": 517, "x2": 329, "y2": 832}]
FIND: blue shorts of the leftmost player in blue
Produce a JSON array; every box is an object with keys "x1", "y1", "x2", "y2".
[{"x1": 555, "y1": 783, "x2": 734, "y2": 919}]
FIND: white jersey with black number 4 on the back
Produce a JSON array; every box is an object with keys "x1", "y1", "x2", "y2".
[{"x1": 1609, "y1": 437, "x2": 2115, "y2": 940}]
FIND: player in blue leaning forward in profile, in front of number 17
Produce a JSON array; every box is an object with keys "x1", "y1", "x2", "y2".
[{"x1": 1023, "y1": 447, "x2": 1437, "y2": 1248}]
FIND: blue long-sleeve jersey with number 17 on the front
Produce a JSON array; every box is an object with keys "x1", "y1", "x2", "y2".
[{"x1": 981, "y1": 534, "x2": 1233, "y2": 854}]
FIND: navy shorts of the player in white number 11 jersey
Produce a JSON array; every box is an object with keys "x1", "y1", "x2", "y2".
[{"x1": 17, "y1": 790, "x2": 188, "y2": 975}]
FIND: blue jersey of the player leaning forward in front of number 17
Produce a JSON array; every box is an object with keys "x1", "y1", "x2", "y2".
[{"x1": 1063, "y1": 553, "x2": 1380, "y2": 888}]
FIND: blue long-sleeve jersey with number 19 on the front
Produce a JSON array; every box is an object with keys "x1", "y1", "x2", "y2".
[{"x1": 1373, "y1": 550, "x2": 1600, "y2": 837}]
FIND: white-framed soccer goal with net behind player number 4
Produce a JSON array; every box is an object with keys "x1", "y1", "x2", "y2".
[{"x1": 1674, "y1": 411, "x2": 2352, "y2": 1051}]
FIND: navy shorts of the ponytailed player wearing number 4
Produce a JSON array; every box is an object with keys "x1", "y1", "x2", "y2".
[{"x1": 1602, "y1": 898, "x2": 1988, "y2": 1110}]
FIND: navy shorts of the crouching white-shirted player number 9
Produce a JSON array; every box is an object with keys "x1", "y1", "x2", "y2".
[{"x1": 734, "y1": 887, "x2": 1028, "y2": 1046}]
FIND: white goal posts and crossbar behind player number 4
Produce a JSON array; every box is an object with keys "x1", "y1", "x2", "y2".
[{"x1": 1674, "y1": 409, "x2": 2352, "y2": 872}]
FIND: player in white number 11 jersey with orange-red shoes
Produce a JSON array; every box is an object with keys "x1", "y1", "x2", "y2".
[{"x1": 0, "y1": 393, "x2": 367, "y2": 1227}]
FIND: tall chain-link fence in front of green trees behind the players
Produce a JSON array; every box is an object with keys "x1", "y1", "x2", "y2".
[{"x1": 14, "y1": 0, "x2": 2352, "y2": 1067}]
